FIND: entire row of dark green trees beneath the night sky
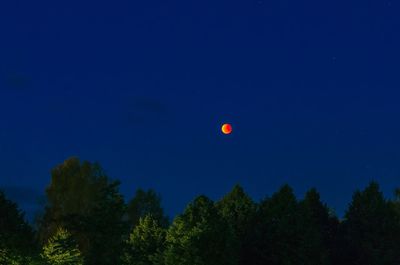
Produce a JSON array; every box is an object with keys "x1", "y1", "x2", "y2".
[{"x1": 0, "y1": 158, "x2": 400, "y2": 265}]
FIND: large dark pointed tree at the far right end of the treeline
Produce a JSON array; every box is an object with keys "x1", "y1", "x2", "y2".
[{"x1": 341, "y1": 182, "x2": 400, "y2": 265}]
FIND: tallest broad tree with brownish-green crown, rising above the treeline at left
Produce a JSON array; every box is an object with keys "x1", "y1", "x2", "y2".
[{"x1": 40, "y1": 158, "x2": 108, "y2": 242}]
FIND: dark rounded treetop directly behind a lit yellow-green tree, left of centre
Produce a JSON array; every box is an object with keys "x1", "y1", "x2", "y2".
[{"x1": 128, "y1": 189, "x2": 169, "y2": 227}]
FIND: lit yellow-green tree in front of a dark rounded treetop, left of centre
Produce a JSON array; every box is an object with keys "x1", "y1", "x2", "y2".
[{"x1": 124, "y1": 215, "x2": 166, "y2": 265}]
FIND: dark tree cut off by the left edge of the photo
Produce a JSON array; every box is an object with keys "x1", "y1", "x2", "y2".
[{"x1": 0, "y1": 191, "x2": 36, "y2": 256}]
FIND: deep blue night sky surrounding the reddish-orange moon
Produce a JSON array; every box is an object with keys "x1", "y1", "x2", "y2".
[{"x1": 0, "y1": 0, "x2": 400, "y2": 219}]
